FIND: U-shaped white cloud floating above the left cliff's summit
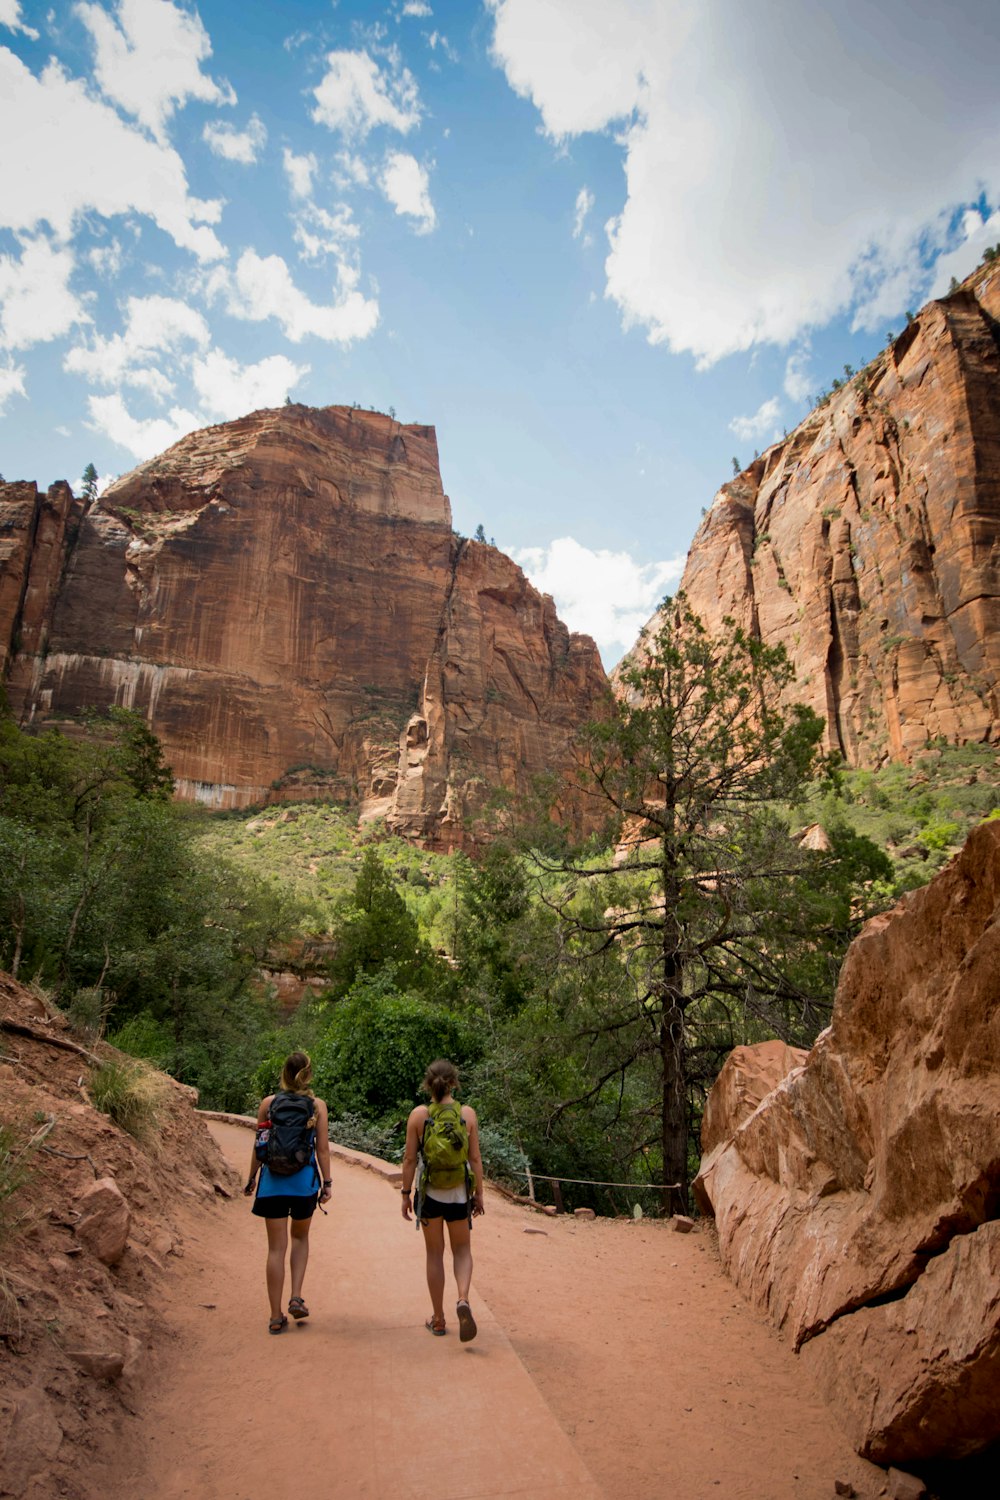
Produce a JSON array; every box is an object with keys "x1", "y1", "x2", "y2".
[{"x1": 208, "y1": 251, "x2": 378, "y2": 344}]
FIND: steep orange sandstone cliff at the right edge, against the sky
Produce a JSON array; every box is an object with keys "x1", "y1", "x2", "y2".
[{"x1": 641, "y1": 269, "x2": 1000, "y2": 765}]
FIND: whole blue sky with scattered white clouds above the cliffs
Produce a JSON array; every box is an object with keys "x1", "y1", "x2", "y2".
[{"x1": 0, "y1": 0, "x2": 1000, "y2": 665}]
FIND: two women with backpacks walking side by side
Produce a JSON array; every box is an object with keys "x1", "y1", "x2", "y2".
[{"x1": 243, "y1": 1052, "x2": 484, "y2": 1343}]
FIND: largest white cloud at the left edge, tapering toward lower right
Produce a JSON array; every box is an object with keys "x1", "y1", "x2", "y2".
[{"x1": 0, "y1": 48, "x2": 226, "y2": 261}]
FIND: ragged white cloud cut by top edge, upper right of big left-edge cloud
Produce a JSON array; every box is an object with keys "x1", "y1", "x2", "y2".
[{"x1": 76, "y1": 0, "x2": 235, "y2": 141}]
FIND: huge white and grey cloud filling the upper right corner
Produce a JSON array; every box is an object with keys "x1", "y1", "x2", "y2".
[{"x1": 487, "y1": 0, "x2": 1000, "y2": 365}]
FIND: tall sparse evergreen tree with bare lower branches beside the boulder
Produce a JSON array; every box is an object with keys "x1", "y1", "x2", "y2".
[{"x1": 540, "y1": 596, "x2": 822, "y2": 1209}]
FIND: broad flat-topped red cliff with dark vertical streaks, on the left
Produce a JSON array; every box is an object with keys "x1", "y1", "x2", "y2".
[{"x1": 0, "y1": 407, "x2": 606, "y2": 845}]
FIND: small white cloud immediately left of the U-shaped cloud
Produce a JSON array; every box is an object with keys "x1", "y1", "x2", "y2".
[{"x1": 63, "y1": 297, "x2": 210, "y2": 393}]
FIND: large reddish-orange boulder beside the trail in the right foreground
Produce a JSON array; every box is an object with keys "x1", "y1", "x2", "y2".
[{"x1": 696, "y1": 822, "x2": 1000, "y2": 1463}]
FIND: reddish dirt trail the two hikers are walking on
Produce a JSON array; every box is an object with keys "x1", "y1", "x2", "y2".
[{"x1": 108, "y1": 1125, "x2": 885, "y2": 1500}]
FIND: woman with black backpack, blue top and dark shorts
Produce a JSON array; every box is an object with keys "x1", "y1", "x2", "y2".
[{"x1": 243, "y1": 1052, "x2": 331, "y2": 1334}]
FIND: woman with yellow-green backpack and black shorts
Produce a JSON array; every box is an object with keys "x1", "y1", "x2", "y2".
[{"x1": 402, "y1": 1058, "x2": 484, "y2": 1344}]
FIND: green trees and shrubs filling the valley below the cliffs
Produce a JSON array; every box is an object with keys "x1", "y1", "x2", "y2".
[{"x1": 0, "y1": 624, "x2": 1000, "y2": 1214}]
